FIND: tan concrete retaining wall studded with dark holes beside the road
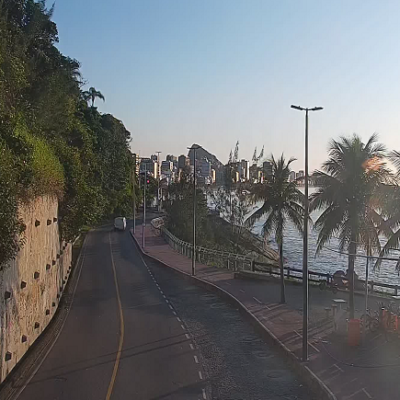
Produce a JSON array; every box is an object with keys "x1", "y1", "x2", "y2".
[{"x1": 0, "y1": 196, "x2": 72, "y2": 382}]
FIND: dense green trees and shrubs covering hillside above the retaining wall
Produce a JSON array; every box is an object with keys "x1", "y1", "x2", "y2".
[{"x1": 0, "y1": 0, "x2": 133, "y2": 265}]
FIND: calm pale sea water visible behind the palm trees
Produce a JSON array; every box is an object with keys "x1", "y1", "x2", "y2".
[{"x1": 253, "y1": 188, "x2": 400, "y2": 285}]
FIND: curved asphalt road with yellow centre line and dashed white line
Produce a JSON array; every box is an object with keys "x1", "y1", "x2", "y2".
[{"x1": 18, "y1": 228, "x2": 310, "y2": 400}]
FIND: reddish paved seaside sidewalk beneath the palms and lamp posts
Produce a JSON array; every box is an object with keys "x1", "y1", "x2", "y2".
[{"x1": 135, "y1": 226, "x2": 400, "y2": 400}]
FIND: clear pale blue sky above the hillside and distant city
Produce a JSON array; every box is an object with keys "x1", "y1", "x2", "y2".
[{"x1": 54, "y1": 0, "x2": 400, "y2": 169}]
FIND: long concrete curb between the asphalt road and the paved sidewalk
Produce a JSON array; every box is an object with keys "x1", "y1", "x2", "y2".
[{"x1": 129, "y1": 230, "x2": 337, "y2": 400}]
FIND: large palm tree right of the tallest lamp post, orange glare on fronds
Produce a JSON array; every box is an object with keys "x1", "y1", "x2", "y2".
[{"x1": 310, "y1": 135, "x2": 389, "y2": 318}]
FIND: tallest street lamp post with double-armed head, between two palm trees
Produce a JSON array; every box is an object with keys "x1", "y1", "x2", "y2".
[{"x1": 291, "y1": 105, "x2": 322, "y2": 361}]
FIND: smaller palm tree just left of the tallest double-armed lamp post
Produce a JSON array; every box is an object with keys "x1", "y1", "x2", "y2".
[{"x1": 247, "y1": 154, "x2": 304, "y2": 303}]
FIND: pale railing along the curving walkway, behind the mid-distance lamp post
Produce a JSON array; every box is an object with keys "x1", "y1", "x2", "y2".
[{"x1": 151, "y1": 218, "x2": 253, "y2": 271}]
